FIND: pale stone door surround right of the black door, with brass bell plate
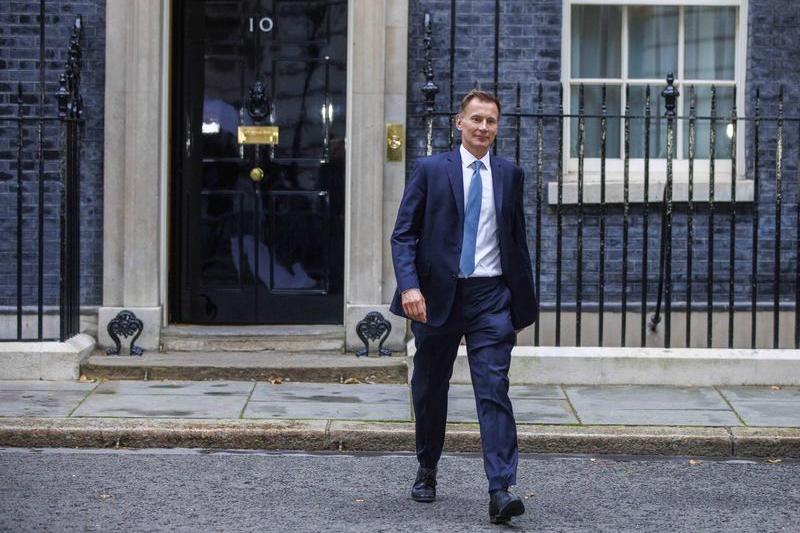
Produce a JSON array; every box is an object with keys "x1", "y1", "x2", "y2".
[{"x1": 344, "y1": 0, "x2": 408, "y2": 352}]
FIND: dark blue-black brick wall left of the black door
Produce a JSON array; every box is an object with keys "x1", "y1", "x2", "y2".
[{"x1": 0, "y1": 0, "x2": 105, "y2": 305}]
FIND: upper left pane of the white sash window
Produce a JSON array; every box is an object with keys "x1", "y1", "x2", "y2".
[{"x1": 571, "y1": 6, "x2": 622, "y2": 78}]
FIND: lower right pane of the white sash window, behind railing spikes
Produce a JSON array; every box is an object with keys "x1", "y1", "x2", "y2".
[{"x1": 683, "y1": 87, "x2": 734, "y2": 159}]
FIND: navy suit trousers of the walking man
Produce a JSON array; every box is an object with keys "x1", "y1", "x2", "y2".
[{"x1": 411, "y1": 276, "x2": 518, "y2": 491}]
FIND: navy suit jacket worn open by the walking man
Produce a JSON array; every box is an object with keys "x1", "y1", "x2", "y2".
[{"x1": 390, "y1": 149, "x2": 538, "y2": 329}]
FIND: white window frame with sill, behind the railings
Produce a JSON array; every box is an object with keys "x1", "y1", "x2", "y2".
[{"x1": 548, "y1": 0, "x2": 753, "y2": 204}]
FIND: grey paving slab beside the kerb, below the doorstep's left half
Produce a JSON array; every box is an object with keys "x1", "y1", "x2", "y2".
[{"x1": 72, "y1": 393, "x2": 247, "y2": 418}]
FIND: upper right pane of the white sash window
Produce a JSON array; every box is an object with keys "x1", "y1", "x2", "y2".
[{"x1": 685, "y1": 7, "x2": 736, "y2": 80}]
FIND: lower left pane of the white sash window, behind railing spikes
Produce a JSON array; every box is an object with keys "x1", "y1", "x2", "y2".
[{"x1": 570, "y1": 85, "x2": 620, "y2": 159}]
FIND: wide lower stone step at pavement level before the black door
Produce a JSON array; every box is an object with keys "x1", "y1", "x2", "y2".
[{"x1": 80, "y1": 351, "x2": 408, "y2": 383}]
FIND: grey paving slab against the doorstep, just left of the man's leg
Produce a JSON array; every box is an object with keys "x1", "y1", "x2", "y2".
[{"x1": 251, "y1": 383, "x2": 411, "y2": 406}]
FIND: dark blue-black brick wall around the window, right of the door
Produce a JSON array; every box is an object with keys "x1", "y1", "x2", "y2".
[{"x1": 407, "y1": 0, "x2": 800, "y2": 314}]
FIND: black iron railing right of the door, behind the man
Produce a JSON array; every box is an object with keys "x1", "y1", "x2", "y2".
[{"x1": 416, "y1": 15, "x2": 800, "y2": 348}]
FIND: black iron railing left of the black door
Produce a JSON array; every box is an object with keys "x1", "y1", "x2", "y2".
[{"x1": 0, "y1": 9, "x2": 83, "y2": 341}]
